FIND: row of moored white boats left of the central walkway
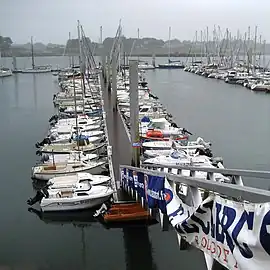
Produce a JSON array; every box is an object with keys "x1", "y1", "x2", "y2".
[{"x1": 28, "y1": 70, "x2": 113, "y2": 212}]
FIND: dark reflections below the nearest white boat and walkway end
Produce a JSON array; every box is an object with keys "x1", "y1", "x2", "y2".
[{"x1": 28, "y1": 208, "x2": 157, "y2": 270}]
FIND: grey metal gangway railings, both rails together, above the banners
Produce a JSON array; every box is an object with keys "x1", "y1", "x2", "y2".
[{"x1": 123, "y1": 165, "x2": 270, "y2": 202}]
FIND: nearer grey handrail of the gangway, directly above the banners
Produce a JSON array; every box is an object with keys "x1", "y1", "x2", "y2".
[{"x1": 120, "y1": 165, "x2": 270, "y2": 203}]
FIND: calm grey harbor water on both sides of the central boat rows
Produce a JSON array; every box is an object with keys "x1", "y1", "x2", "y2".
[{"x1": 0, "y1": 57, "x2": 270, "y2": 270}]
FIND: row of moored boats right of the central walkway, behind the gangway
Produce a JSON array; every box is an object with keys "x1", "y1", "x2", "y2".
[{"x1": 117, "y1": 69, "x2": 229, "y2": 181}]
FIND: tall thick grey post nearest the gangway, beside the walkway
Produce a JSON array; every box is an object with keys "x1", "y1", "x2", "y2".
[{"x1": 129, "y1": 60, "x2": 140, "y2": 167}]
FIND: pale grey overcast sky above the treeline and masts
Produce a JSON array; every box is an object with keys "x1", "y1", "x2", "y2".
[{"x1": 0, "y1": 0, "x2": 270, "y2": 44}]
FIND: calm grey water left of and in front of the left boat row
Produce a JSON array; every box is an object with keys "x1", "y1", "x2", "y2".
[{"x1": 0, "y1": 57, "x2": 205, "y2": 270}]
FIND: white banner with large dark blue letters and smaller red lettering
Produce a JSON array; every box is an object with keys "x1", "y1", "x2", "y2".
[{"x1": 165, "y1": 179, "x2": 270, "y2": 270}]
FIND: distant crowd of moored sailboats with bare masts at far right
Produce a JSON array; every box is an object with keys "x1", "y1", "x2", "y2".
[{"x1": 184, "y1": 26, "x2": 269, "y2": 93}]
